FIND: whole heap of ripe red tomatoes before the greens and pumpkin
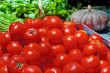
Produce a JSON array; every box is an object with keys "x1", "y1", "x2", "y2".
[{"x1": 0, "y1": 16, "x2": 110, "y2": 73}]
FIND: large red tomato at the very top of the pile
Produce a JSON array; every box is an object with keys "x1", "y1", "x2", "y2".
[{"x1": 46, "y1": 16, "x2": 63, "y2": 29}]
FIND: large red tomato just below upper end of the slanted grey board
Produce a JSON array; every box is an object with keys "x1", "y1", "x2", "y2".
[{"x1": 74, "y1": 30, "x2": 89, "y2": 50}]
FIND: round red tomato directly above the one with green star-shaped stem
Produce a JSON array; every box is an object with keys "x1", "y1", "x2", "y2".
[{"x1": 7, "y1": 41, "x2": 23, "y2": 55}]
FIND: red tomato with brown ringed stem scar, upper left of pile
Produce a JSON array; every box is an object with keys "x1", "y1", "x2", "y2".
[{"x1": 23, "y1": 28, "x2": 40, "y2": 42}]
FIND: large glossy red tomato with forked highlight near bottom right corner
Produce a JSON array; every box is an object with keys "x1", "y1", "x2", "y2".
[{"x1": 82, "y1": 55, "x2": 100, "y2": 73}]
